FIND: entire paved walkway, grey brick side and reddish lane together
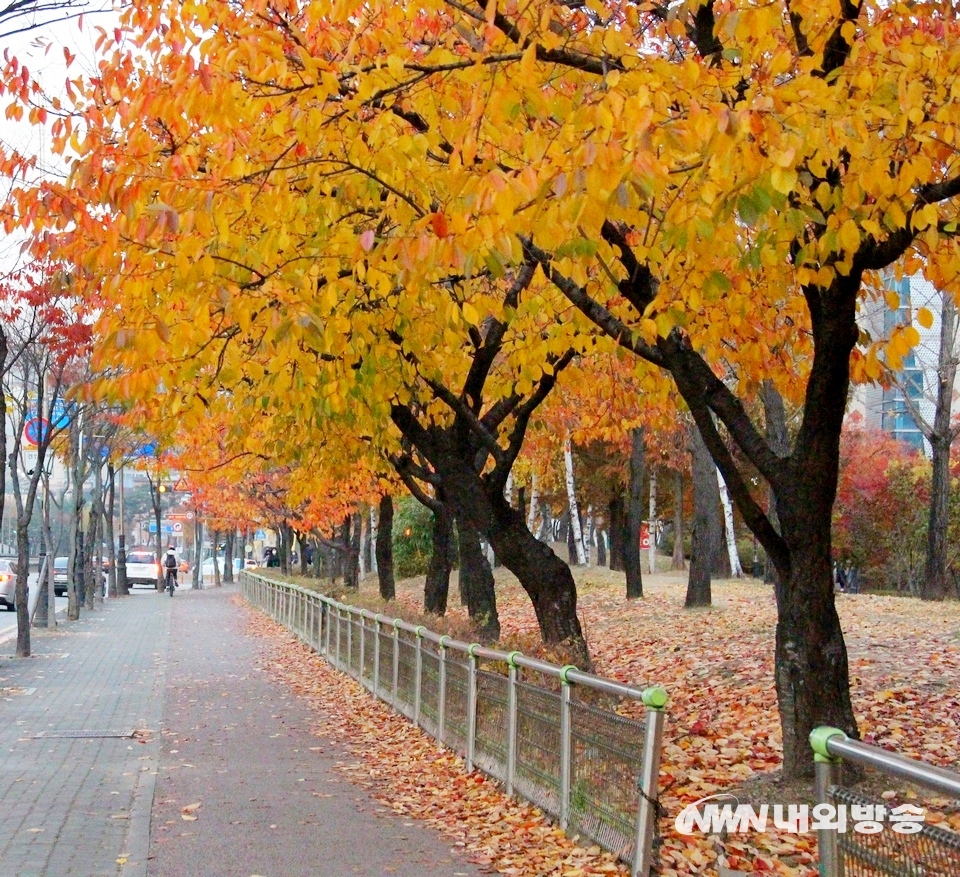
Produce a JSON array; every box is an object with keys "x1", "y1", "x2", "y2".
[{"x1": 0, "y1": 588, "x2": 482, "y2": 877}]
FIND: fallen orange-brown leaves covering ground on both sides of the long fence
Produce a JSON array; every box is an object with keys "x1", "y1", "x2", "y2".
[{"x1": 240, "y1": 567, "x2": 960, "y2": 877}]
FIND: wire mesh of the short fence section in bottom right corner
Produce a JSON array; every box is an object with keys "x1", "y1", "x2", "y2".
[{"x1": 830, "y1": 786, "x2": 960, "y2": 877}]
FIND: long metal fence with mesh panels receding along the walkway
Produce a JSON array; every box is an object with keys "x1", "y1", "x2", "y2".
[{"x1": 240, "y1": 571, "x2": 667, "y2": 877}]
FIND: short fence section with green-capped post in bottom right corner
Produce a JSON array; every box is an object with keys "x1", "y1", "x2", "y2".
[{"x1": 810, "y1": 728, "x2": 960, "y2": 877}]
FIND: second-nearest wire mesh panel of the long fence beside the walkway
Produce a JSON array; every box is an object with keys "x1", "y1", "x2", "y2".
[{"x1": 513, "y1": 682, "x2": 561, "y2": 817}]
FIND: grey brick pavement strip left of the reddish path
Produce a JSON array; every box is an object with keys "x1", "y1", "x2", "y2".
[{"x1": 0, "y1": 591, "x2": 172, "y2": 877}]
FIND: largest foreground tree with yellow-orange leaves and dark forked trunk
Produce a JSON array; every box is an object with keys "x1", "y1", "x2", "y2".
[{"x1": 11, "y1": 0, "x2": 960, "y2": 776}]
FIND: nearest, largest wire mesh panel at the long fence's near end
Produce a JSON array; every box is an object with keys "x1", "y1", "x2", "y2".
[{"x1": 569, "y1": 698, "x2": 645, "y2": 861}]
